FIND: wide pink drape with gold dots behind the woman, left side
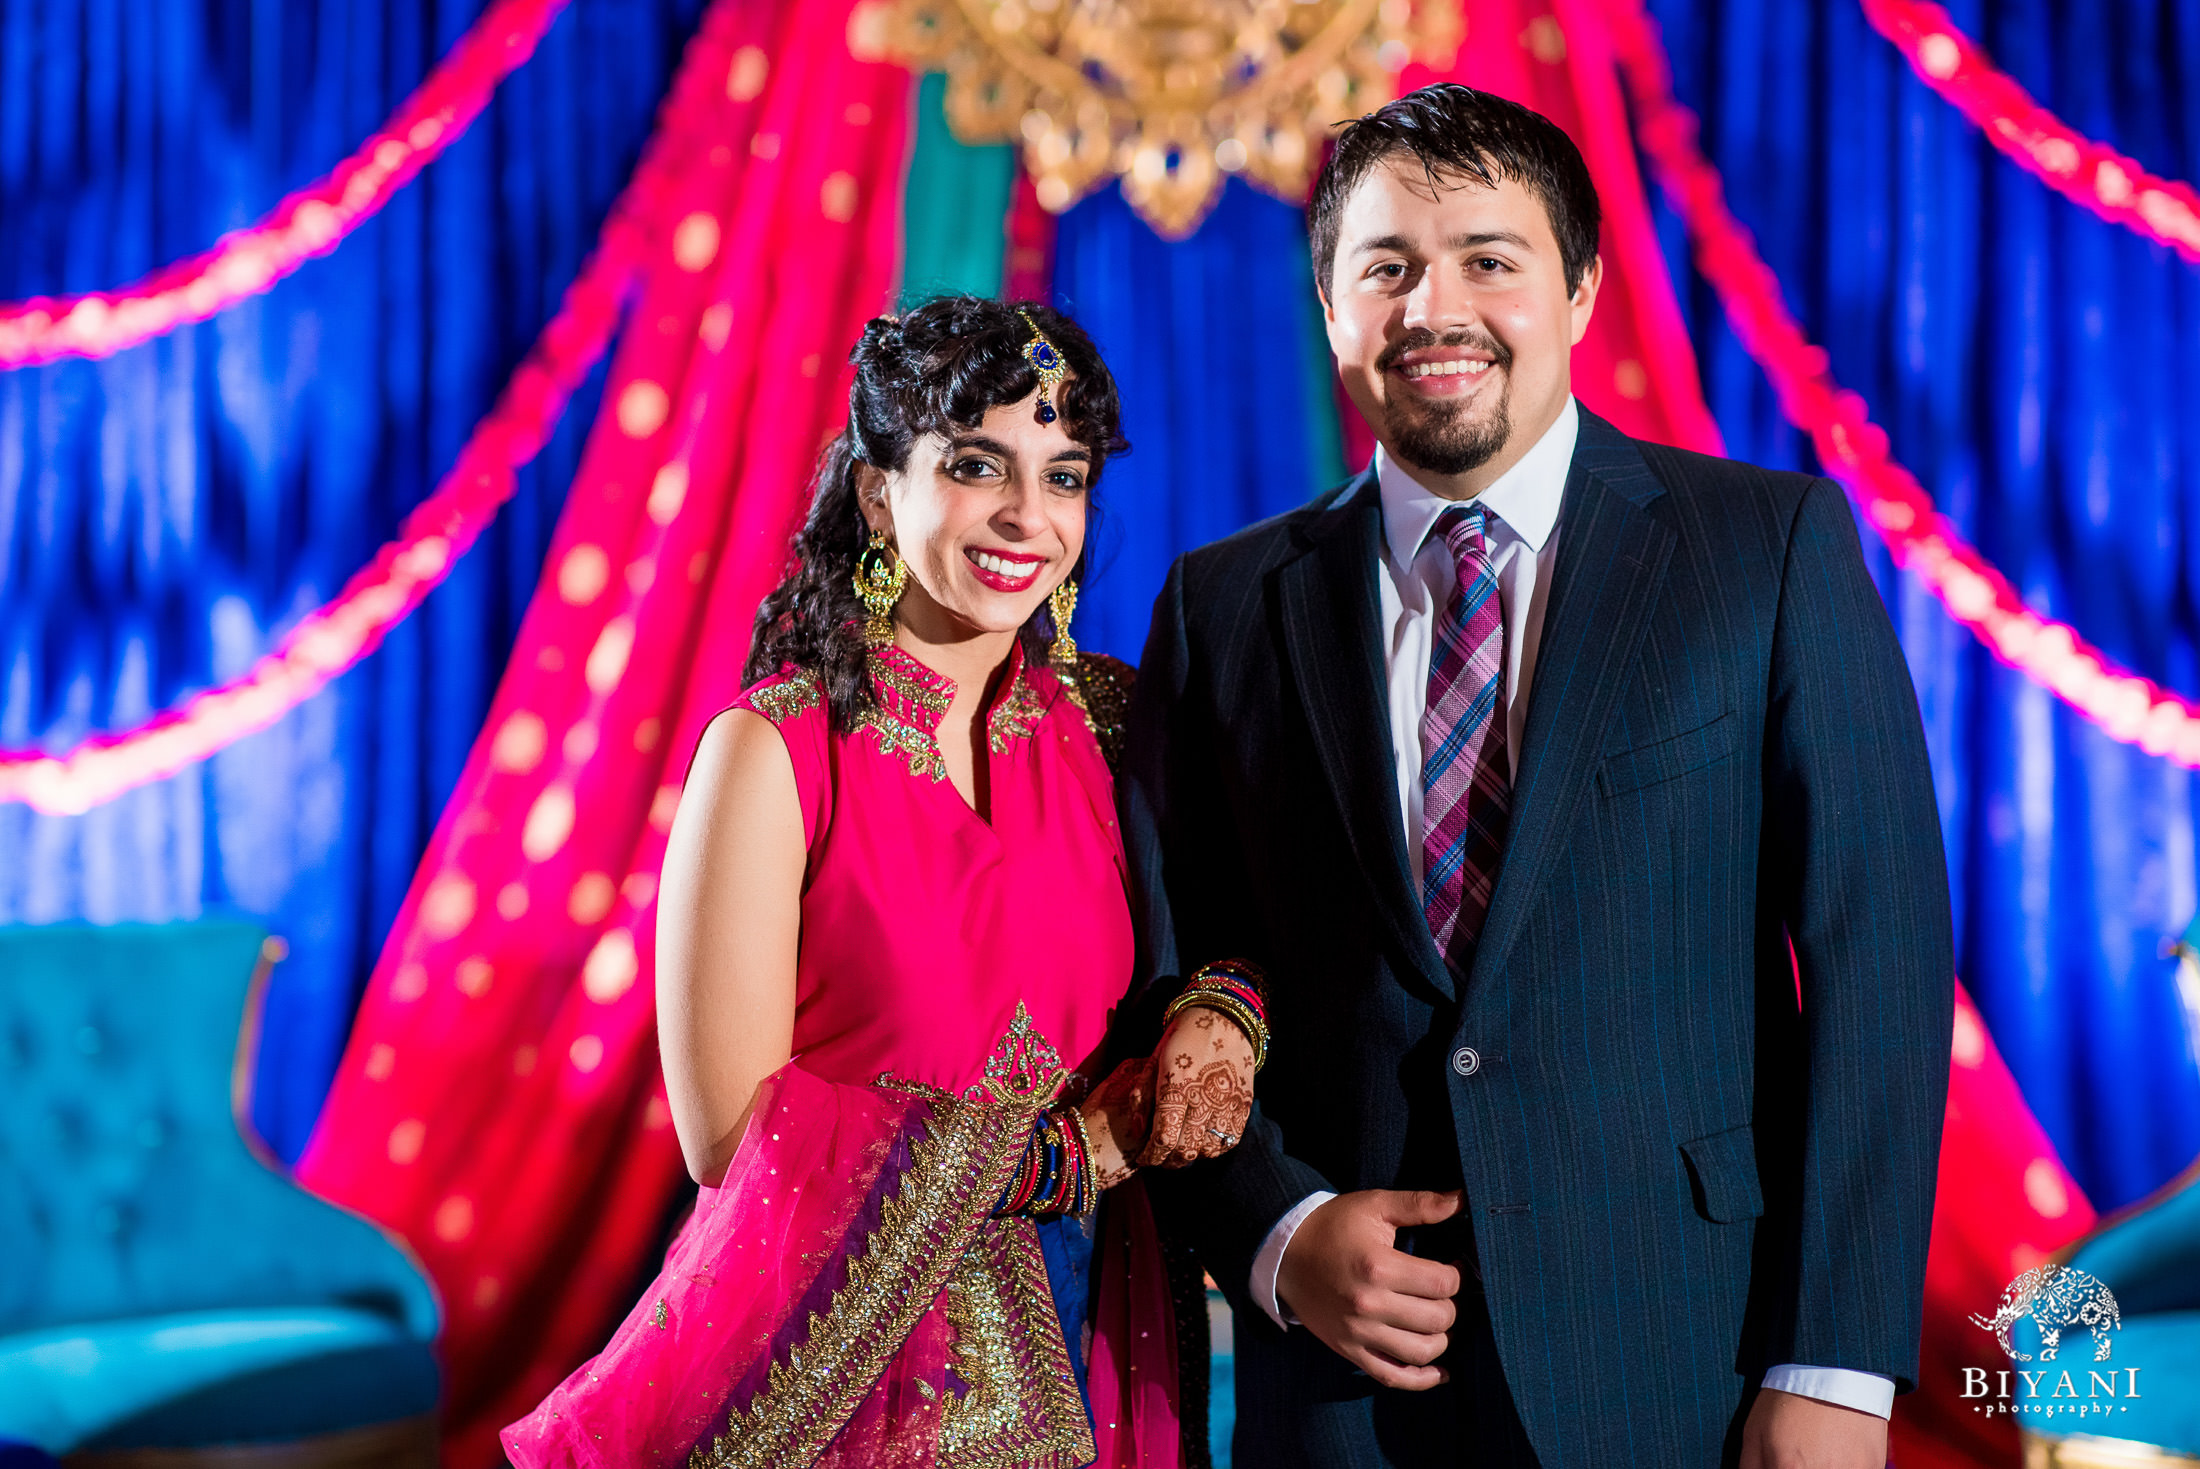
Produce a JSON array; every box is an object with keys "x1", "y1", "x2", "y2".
[{"x1": 299, "y1": 0, "x2": 909, "y2": 1465}]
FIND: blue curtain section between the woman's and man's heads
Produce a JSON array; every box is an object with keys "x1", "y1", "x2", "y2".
[{"x1": 1054, "y1": 180, "x2": 1344, "y2": 662}]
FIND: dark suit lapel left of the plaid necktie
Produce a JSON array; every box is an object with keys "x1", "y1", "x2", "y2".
[{"x1": 1276, "y1": 471, "x2": 1456, "y2": 1001}]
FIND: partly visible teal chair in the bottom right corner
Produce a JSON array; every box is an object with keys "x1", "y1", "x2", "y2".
[{"x1": 2009, "y1": 1163, "x2": 2200, "y2": 1469}]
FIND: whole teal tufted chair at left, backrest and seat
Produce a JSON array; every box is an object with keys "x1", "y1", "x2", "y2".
[{"x1": 0, "y1": 921, "x2": 440, "y2": 1469}]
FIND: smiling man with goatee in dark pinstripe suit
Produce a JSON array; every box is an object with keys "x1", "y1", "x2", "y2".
[{"x1": 1122, "y1": 86, "x2": 1954, "y2": 1469}]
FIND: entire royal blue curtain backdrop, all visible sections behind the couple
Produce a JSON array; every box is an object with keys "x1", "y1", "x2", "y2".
[{"x1": 17, "y1": 0, "x2": 2200, "y2": 1231}]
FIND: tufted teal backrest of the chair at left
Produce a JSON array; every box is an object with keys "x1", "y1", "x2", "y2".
[{"x1": 0, "y1": 921, "x2": 440, "y2": 1341}]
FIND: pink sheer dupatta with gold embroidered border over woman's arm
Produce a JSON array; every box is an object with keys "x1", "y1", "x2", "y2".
[{"x1": 504, "y1": 1064, "x2": 1179, "y2": 1469}]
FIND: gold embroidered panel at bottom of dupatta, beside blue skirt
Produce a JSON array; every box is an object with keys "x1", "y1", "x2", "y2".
[{"x1": 939, "y1": 1218, "x2": 1096, "y2": 1469}]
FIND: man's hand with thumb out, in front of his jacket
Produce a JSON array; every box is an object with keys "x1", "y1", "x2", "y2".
[{"x1": 1276, "y1": 1190, "x2": 1461, "y2": 1392}]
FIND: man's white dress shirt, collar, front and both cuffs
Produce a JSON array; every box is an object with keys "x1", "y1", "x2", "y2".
[{"x1": 1250, "y1": 398, "x2": 1894, "y2": 1418}]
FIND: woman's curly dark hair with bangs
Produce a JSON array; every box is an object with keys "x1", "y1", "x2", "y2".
[{"x1": 744, "y1": 297, "x2": 1129, "y2": 730}]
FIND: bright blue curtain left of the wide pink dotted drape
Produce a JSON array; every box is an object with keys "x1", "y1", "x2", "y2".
[{"x1": 0, "y1": 0, "x2": 700, "y2": 1157}]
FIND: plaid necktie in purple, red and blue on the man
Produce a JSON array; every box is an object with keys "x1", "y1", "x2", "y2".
[{"x1": 1421, "y1": 504, "x2": 1511, "y2": 970}]
